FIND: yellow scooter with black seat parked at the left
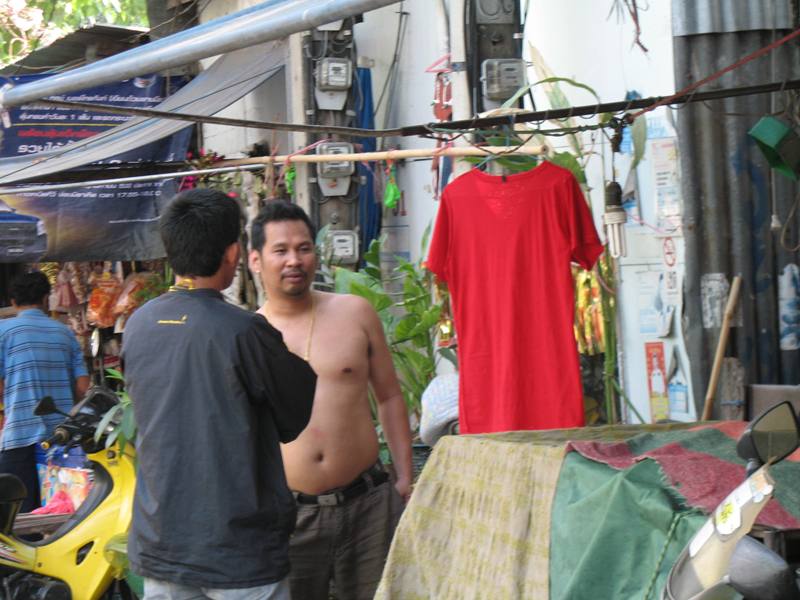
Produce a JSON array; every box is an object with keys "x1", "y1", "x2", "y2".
[{"x1": 0, "y1": 387, "x2": 136, "y2": 600}]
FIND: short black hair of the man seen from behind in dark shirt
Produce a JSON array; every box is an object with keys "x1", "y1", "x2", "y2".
[{"x1": 158, "y1": 188, "x2": 242, "y2": 277}]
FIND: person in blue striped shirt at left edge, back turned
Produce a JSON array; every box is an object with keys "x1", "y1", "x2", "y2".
[{"x1": 0, "y1": 271, "x2": 89, "y2": 512}]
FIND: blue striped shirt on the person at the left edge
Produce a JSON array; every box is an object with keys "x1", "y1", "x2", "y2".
[{"x1": 0, "y1": 308, "x2": 87, "y2": 450}]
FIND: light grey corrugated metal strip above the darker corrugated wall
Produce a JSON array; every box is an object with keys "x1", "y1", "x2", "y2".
[{"x1": 672, "y1": 0, "x2": 792, "y2": 37}]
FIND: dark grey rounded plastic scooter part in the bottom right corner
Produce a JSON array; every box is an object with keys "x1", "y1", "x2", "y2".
[{"x1": 728, "y1": 536, "x2": 800, "y2": 600}]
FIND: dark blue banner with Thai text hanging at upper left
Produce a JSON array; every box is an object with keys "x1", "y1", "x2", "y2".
[{"x1": 0, "y1": 75, "x2": 191, "y2": 262}]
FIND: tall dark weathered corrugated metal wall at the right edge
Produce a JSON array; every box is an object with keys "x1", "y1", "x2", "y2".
[{"x1": 674, "y1": 0, "x2": 800, "y2": 414}]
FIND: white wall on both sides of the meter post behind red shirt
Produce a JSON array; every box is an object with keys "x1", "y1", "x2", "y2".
[{"x1": 356, "y1": 0, "x2": 694, "y2": 421}]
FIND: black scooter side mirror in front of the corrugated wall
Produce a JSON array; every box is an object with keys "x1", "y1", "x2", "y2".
[{"x1": 736, "y1": 402, "x2": 800, "y2": 464}]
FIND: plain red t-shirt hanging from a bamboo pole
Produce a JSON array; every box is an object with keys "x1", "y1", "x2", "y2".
[{"x1": 427, "y1": 161, "x2": 603, "y2": 433}]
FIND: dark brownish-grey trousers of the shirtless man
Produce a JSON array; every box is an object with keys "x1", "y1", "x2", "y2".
[{"x1": 289, "y1": 481, "x2": 404, "y2": 600}]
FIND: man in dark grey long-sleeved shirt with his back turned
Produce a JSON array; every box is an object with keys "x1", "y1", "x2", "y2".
[{"x1": 122, "y1": 189, "x2": 316, "y2": 600}]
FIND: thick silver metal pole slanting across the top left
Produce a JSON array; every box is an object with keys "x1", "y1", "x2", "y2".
[{"x1": 0, "y1": 0, "x2": 398, "y2": 109}]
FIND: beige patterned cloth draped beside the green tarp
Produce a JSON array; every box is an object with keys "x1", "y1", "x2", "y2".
[{"x1": 375, "y1": 434, "x2": 564, "y2": 600}]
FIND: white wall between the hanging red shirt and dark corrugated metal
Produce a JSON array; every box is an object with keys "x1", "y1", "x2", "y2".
[{"x1": 525, "y1": 0, "x2": 695, "y2": 422}]
